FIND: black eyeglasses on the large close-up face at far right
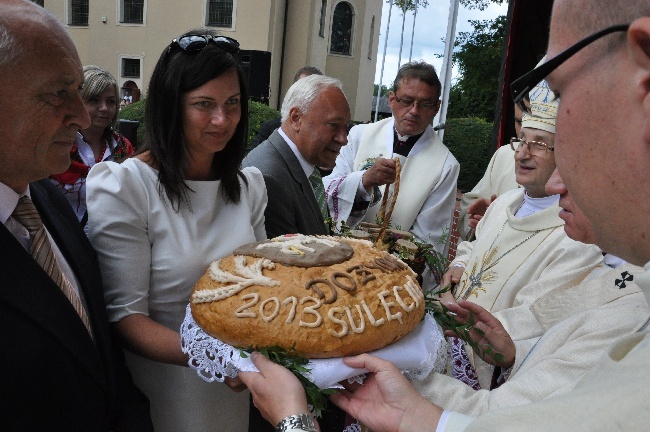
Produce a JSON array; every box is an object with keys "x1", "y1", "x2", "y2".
[{"x1": 510, "y1": 24, "x2": 630, "y2": 114}]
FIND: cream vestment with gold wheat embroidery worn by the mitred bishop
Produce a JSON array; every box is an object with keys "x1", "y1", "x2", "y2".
[{"x1": 452, "y1": 189, "x2": 602, "y2": 388}]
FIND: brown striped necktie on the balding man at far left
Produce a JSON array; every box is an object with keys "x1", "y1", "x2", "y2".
[{"x1": 11, "y1": 196, "x2": 93, "y2": 338}]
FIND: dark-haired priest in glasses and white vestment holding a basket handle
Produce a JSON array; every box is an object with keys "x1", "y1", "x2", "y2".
[{"x1": 323, "y1": 62, "x2": 460, "y2": 255}]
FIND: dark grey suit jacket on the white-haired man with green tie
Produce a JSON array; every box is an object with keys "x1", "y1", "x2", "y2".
[{"x1": 244, "y1": 131, "x2": 329, "y2": 238}]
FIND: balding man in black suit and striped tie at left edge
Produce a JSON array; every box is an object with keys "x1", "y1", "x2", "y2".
[{"x1": 0, "y1": 0, "x2": 153, "y2": 432}]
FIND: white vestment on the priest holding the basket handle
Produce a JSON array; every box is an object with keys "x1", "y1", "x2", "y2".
[{"x1": 323, "y1": 118, "x2": 459, "y2": 253}]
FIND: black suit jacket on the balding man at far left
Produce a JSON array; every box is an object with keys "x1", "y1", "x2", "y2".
[{"x1": 0, "y1": 180, "x2": 153, "y2": 432}]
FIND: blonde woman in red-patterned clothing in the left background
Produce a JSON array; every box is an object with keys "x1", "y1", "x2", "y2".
[{"x1": 50, "y1": 65, "x2": 134, "y2": 233}]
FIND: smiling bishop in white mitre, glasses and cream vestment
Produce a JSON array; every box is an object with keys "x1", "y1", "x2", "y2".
[{"x1": 442, "y1": 82, "x2": 602, "y2": 390}]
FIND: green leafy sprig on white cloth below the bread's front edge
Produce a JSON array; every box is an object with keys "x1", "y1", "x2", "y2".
[{"x1": 240, "y1": 344, "x2": 336, "y2": 417}]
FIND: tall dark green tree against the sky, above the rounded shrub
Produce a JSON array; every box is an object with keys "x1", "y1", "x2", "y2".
[{"x1": 447, "y1": 16, "x2": 506, "y2": 122}]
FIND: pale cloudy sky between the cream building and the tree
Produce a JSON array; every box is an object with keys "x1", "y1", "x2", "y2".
[{"x1": 375, "y1": 0, "x2": 508, "y2": 86}]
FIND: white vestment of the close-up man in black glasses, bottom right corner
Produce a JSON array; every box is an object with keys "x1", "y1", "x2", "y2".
[{"x1": 444, "y1": 263, "x2": 650, "y2": 432}]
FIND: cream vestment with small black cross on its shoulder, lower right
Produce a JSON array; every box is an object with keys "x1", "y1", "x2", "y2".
[{"x1": 413, "y1": 264, "x2": 650, "y2": 415}]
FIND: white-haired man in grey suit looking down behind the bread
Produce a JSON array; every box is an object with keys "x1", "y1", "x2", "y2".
[{"x1": 244, "y1": 75, "x2": 350, "y2": 238}]
